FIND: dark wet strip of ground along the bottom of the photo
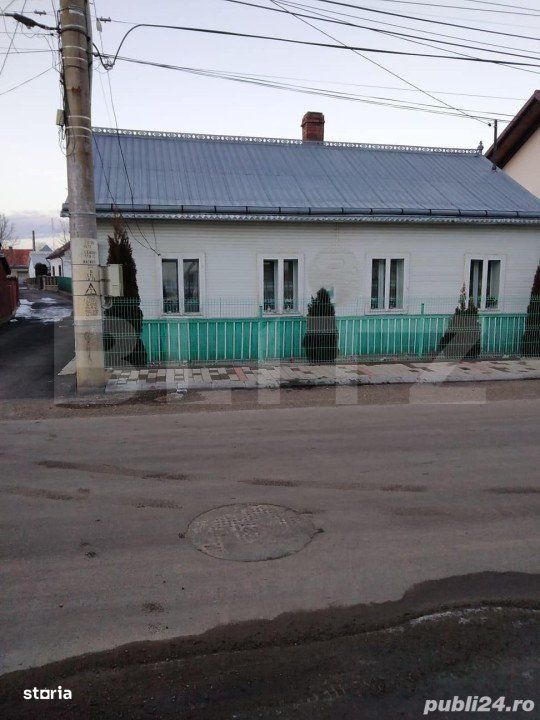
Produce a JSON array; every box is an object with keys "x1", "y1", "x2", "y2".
[{"x1": 0, "y1": 596, "x2": 540, "y2": 720}]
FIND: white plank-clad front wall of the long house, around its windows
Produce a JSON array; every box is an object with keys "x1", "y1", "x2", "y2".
[{"x1": 98, "y1": 220, "x2": 540, "y2": 317}]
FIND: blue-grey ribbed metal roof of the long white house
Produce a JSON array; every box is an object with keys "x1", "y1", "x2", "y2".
[{"x1": 89, "y1": 128, "x2": 540, "y2": 221}]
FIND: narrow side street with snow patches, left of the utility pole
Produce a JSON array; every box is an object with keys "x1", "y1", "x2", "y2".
[{"x1": 0, "y1": 287, "x2": 74, "y2": 401}]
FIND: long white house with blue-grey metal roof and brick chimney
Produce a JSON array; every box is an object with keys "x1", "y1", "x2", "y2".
[{"x1": 71, "y1": 113, "x2": 540, "y2": 366}]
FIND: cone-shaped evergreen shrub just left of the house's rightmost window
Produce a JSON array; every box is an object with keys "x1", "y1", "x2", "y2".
[{"x1": 438, "y1": 285, "x2": 482, "y2": 360}]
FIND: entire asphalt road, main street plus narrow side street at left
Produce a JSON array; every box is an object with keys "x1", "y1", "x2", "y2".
[{"x1": 0, "y1": 330, "x2": 540, "y2": 720}]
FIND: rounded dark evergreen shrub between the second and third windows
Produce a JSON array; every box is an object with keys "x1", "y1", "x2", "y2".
[{"x1": 303, "y1": 288, "x2": 338, "y2": 363}]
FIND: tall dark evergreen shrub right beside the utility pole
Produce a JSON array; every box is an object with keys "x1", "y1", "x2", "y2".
[{"x1": 104, "y1": 218, "x2": 148, "y2": 367}]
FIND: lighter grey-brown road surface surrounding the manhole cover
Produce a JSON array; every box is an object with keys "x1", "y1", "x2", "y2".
[{"x1": 0, "y1": 400, "x2": 540, "y2": 672}]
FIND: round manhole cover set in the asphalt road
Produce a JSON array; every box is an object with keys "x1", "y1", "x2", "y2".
[{"x1": 186, "y1": 504, "x2": 317, "y2": 562}]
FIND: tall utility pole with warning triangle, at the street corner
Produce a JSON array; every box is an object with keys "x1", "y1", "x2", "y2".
[{"x1": 60, "y1": 0, "x2": 105, "y2": 392}]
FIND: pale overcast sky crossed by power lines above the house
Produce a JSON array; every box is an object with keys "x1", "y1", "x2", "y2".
[{"x1": 0, "y1": 0, "x2": 540, "y2": 247}]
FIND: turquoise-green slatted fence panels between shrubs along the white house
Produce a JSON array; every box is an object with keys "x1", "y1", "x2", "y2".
[{"x1": 137, "y1": 314, "x2": 525, "y2": 363}]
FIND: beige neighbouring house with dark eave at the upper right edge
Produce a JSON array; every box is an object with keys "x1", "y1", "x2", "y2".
[{"x1": 486, "y1": 90, "x2": 540, "y2": 197}]
